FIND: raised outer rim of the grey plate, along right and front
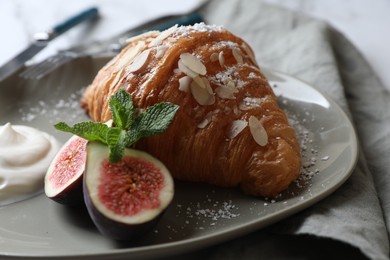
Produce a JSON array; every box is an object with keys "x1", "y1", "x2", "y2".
[{"x1": 0, "y1": 67, "x2": 359, "y2": 259}]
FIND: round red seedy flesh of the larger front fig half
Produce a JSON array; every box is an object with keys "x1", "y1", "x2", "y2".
[{"x1": 98, "y1": 156, "x2": 164, "y2": 216}]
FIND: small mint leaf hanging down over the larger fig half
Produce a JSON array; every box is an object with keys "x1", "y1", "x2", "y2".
[{"x1": 106, "y1": 127, "x2": 128, "y2": 163}]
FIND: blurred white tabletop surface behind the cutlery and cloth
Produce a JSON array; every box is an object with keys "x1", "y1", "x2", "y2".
[{"x1": 0, "y1": 0, "x2": 390, "y2": 89}]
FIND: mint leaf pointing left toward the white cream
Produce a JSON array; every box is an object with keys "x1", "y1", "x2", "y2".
[{"x1": 54, "y1": 122, "x2": 109, "y2": 143}]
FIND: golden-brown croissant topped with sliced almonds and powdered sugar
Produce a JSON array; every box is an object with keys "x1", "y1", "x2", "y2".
[{"x1": 81, "y1": 23, "x2": 301, "y2": 197}]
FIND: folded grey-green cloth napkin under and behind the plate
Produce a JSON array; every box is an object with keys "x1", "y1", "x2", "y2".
[{"x1": 173, "y1": 0, "x2": 390, "y2": 259}]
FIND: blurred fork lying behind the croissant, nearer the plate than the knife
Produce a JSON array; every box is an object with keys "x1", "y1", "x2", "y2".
[{"x1": 19, "y1": 12, "x2": 203, "y2": 80}]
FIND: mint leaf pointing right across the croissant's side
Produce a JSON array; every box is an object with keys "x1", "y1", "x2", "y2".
[{"x1": 135, "y1": 102, "x2": 179, "y2": 138}]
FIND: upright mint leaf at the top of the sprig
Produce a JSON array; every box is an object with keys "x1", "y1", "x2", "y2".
[{"x1": 109, "y1": 89, "x2": 134, "y2": 129}]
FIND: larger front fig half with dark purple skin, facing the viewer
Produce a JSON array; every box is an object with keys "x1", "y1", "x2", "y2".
[{"x1": 83, "y1": 142, "x2": 174, "y2": 240}]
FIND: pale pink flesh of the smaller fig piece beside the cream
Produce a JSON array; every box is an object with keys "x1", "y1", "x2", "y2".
[{"x1": 49, "y1": 138, "x2": 88, "y2": 189}]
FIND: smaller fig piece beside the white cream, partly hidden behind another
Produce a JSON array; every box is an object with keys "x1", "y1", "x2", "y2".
[{"x1": 45, "y1": 135, "x2": 88, "y2": 206}]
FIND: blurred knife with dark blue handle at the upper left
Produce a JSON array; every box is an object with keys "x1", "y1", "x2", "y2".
[{"x1": 0, "y1": 7, "x2": 98, "y2": 81}]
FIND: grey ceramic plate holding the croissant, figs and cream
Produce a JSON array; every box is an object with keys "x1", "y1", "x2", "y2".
[{"x1": 0, "y1": 59, "x2": 357, "y2": 259}]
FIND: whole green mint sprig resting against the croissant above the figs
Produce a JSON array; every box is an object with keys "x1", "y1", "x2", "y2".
[{"x1": 54, "y1": 89, "x2": 179, "y2": 163}]
